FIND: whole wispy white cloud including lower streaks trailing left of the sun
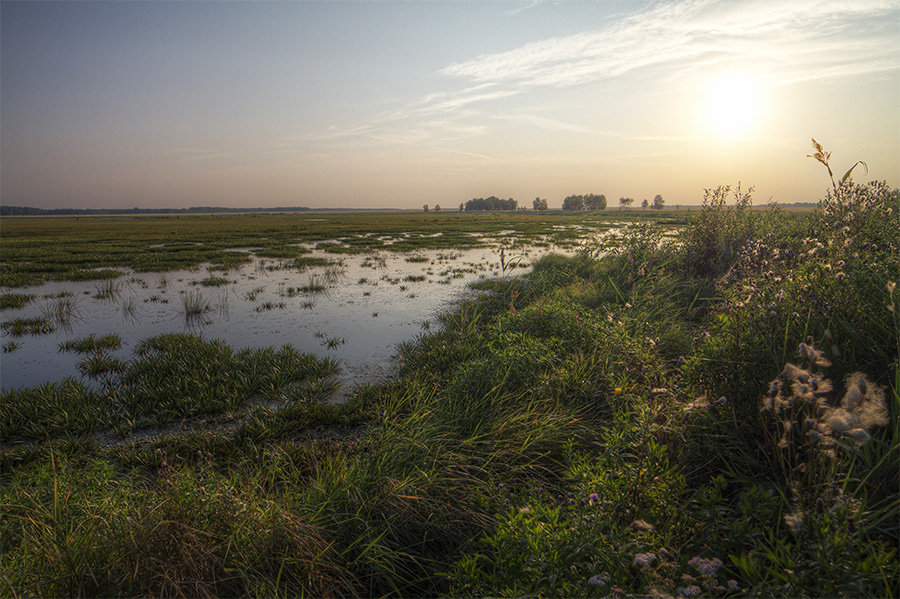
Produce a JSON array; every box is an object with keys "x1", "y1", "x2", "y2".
[{"x1": 298, "y1": 0, "x2": 900, "y2": 159}]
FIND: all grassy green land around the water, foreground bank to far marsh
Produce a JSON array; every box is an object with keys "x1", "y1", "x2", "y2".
[{"x1": 0, "y1": 183, "x2": 900, "y2": 597}]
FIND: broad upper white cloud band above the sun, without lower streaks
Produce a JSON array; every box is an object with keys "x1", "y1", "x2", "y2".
[{"x1": 441, "y1": 0, "x2": 900, "y2": 89}]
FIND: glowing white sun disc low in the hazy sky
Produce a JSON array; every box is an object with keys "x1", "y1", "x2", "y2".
[{"x1": 703, "y1": 71, "x2": 761, "y2": 138}]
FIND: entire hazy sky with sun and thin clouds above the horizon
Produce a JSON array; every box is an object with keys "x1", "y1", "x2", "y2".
[{"x1": 0, "y1": 0, "x2": 900, "y2": 209}]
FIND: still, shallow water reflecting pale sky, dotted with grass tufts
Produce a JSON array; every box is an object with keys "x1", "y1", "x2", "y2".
[{"x1": 0, "y1": 237, "x2": 588, "y2": 396}]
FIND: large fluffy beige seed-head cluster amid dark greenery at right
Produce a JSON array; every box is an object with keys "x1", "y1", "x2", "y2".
[{"x1": 762, "y1": 340, "x2": 888, "y2": 458}]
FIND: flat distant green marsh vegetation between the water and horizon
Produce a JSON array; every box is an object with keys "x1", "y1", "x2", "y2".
[{"x1": 0, "y1": 210, "x2": 648, "y2": 288}]
